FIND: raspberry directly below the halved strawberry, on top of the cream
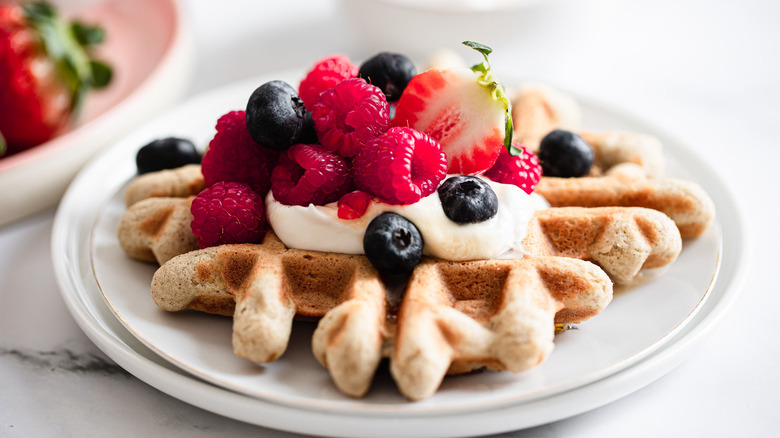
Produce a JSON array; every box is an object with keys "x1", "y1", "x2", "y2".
[{"x1": 352, "y1": 127, "x2": 447, "y2": 205}]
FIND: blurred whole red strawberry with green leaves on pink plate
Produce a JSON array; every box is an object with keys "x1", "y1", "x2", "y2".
[{"x1": 0, "y1": 2, "x2": 111, "y2": 153}]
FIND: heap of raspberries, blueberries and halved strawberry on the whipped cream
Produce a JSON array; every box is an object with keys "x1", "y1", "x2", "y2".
[{"x1": 146, "y1": 43, "x2": 541, "y2": 276}]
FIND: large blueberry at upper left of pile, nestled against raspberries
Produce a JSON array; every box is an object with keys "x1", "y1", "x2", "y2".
[{"x1": 246, "y1": 81, "x2": 306, "y2": 151}]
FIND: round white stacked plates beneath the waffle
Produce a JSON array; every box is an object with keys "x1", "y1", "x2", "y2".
[{"x1": 52, "y1": 72, "x2": 745, "y2": 436}]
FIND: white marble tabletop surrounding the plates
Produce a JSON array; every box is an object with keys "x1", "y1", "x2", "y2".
[{"x1": 0, "y1": 0, "x2": 780, "y2": 437}]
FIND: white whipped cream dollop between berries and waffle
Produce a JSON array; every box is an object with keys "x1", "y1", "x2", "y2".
[{"x1": 265, "y1": 179, "x2": 549, "y2": 261}]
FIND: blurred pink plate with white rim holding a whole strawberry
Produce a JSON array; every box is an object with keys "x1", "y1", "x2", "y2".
[{"x1": 0, "y1": 0, "x2": 193, "y2": 225}]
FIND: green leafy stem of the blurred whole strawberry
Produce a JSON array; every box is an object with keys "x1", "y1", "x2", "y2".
[{"x1": 22, "y1": 2, "x2": 112, "y2": 116}]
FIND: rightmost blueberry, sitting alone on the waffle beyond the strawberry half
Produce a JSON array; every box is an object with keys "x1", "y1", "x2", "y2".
[{"x1": 539, "y1": 129, "x2": 594, "y2": 178}]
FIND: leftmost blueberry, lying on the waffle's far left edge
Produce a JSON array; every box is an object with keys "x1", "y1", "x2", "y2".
[{"x1": 135, "y1": 137, "x2": 201, "y2": 174}]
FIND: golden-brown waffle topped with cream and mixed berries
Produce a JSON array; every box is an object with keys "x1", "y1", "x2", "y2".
[{"x1": 111, "y1": 82, "x2": 696, "y2": 400}]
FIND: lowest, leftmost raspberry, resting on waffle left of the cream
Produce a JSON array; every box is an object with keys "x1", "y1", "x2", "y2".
[{"x1": 190, "y1": 181, "x2": 267, "y2": 248}]
